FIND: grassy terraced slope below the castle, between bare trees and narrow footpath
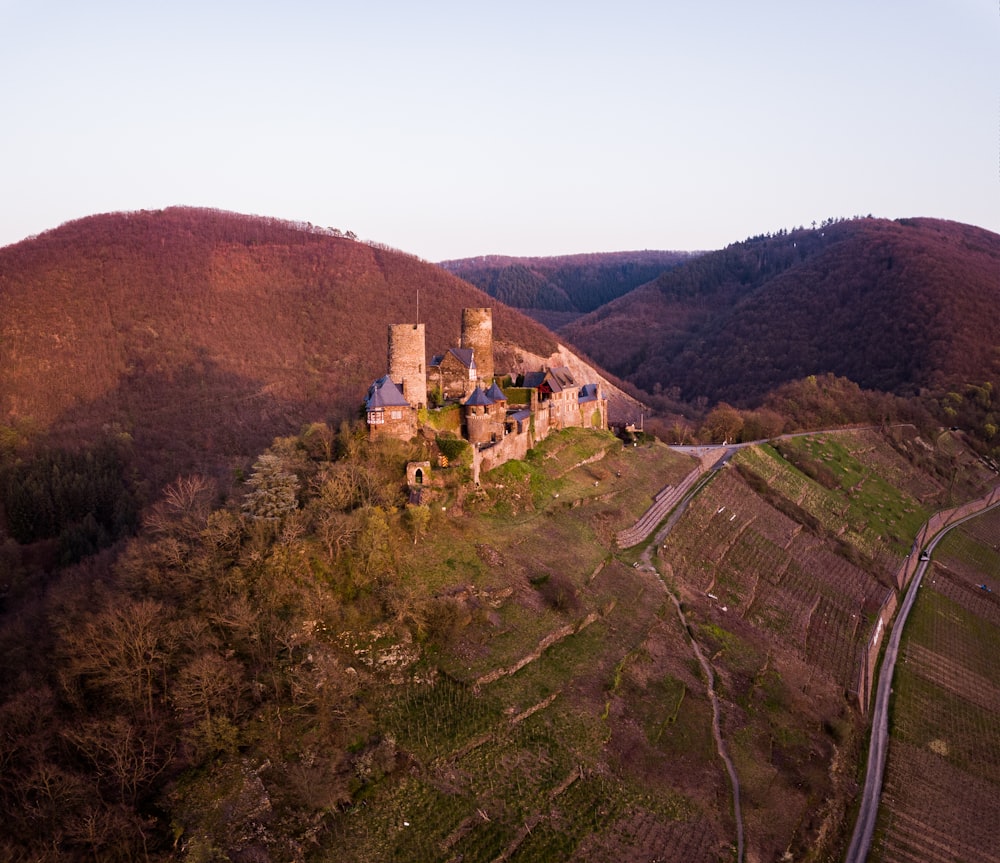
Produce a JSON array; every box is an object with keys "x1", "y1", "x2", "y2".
[{"x1": 324, "y1": 434, "x2": 732, "y2": 863}]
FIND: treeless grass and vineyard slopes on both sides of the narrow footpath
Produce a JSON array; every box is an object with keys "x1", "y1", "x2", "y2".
[{"x1": 318, "y1": 426, "x2": 992, "y2": 860}]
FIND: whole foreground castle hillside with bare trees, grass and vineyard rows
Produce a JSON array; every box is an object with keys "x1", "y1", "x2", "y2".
[{"x1": 0, "y1": 422, "x2": 992, "y2": 863}]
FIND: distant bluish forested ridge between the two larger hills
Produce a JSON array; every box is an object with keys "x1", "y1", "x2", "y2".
[{"x1": 440, "y1": 251, "x2": 693, "y2": 324}]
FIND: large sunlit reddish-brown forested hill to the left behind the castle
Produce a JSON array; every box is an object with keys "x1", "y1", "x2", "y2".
[{"x1": 0, "y1": 208, "x2": 555, "y2": 484}]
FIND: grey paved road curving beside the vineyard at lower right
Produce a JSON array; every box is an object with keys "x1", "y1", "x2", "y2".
[{"x1": 844, "y1": 504, "x2": 997, "y2": 863}]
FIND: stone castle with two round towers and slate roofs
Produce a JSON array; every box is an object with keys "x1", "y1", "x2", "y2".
[{"x1": 365, "y1": 308, "x2": 608, "y2": 482}]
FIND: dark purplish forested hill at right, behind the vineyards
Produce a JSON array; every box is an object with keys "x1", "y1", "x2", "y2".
[{"x1": 564, "y1": 218, "x2": 1000, "y2": 405}]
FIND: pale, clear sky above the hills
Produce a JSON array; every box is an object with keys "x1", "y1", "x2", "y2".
[{"x1": 0, "y1": 0, "x2": 1000, "y2": 261}]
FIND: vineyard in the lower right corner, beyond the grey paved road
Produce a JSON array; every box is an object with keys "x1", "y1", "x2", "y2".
[{"x1": 869, "y1": 511, "x2": 1000, "y2": 863}]
